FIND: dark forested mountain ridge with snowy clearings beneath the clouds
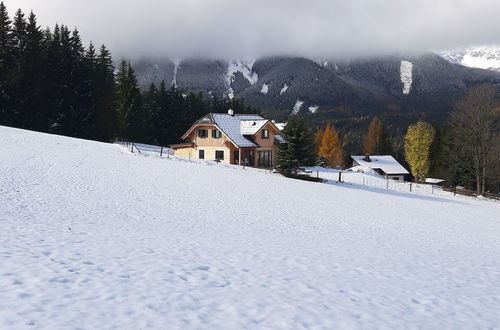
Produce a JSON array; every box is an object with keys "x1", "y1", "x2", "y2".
[{"x1": 134, "y1": 53, "x2": 500, "y2": 125}]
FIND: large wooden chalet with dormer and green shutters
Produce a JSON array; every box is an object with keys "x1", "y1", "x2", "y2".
[{"x1": 170, "y1": 110, "x2": 283, "y2": 167}]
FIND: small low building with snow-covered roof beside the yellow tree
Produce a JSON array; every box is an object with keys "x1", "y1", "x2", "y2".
[{"x1": 351, "y1": 155, "x2": 410, "y2": 181}]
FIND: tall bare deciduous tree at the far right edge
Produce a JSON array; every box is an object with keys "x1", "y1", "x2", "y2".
[{"x1": 451, "y1": 85, "x2": 500, "y2": 194}]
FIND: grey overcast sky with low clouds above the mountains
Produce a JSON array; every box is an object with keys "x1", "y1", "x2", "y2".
[{"x1": 3, "y1": 0, "x2": 500, "y2": 58}]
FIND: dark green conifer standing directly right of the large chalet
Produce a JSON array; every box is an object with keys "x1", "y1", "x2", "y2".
[{"x1": 276, "y1": 116, "x2": 316, "y2": 175}]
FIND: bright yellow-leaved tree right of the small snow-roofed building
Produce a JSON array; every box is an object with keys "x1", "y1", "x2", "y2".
[{"x1": 404, "y1": 121, "x2": 436, "y2": 182}]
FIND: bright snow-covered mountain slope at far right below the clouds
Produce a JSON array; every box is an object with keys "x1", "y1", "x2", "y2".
[{"x1": 439, "y1": 46, "x2": 500, "y2": 71}]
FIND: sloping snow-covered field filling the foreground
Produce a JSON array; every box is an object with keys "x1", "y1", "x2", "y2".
[{"x1": 0, "y1": 127, "x2": 500, "y2": 329}]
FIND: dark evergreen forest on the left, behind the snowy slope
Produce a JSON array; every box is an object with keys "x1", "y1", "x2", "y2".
[{"x1": 0, "y1": 2, "x2": 258, "y2": 145}]
